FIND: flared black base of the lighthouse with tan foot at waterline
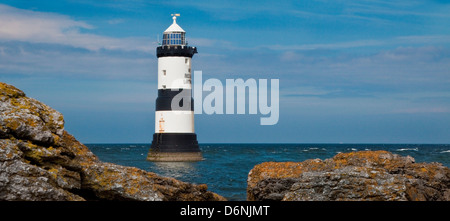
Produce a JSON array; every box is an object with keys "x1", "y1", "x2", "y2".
[{"x1": 147, "y1": 133, "x2": 203, "y2": 162}]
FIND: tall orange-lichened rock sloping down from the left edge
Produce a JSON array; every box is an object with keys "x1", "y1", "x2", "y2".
[{"x1": 0, "y1": 82, "x2": 225, "y2": 201}]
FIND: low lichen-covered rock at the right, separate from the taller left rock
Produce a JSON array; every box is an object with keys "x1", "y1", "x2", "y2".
[{"x1": 247, "y1": 151, "x2": 450, "y2": 201}]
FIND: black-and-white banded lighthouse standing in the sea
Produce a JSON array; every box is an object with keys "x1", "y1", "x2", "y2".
[{"x1": 147, "y1": 14, "x2": 202, "y2": 161}]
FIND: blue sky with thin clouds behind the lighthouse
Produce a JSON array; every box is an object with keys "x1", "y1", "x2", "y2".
[{"x1": 0, "y1": 0, "x2": 450, "y2": 143}]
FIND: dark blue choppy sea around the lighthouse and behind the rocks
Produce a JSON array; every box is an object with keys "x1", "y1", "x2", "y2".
[{"x1": 86, "y1": 144, "x2": 450, "y2": 201}]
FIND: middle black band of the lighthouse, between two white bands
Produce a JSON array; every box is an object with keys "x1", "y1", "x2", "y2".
[{"x1": 156, "y1": 89, "x2": 194, "y2": 111}]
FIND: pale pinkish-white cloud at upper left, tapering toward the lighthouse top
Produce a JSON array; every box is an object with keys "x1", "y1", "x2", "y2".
[{"x1": 0, "y1": 4, "x2": 155, "y2": 52}]
